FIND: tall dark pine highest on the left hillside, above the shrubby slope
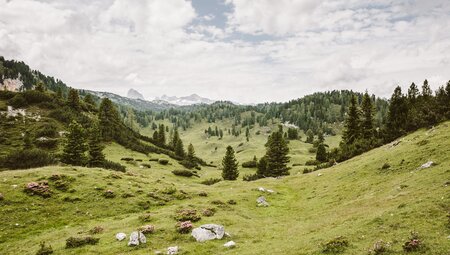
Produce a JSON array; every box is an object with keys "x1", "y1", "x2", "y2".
[{"x1": 98, "y1": 98, "x2": 120, "y2": 141}]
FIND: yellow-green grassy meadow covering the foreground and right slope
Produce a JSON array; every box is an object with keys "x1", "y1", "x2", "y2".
[{"x1": 0, "y1": 122, "x2": 450, "y2": 254}]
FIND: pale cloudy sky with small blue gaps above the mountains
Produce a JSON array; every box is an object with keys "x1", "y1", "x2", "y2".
[{"x1": 0, "y1": 0, "x2": 450, "y2": 103}]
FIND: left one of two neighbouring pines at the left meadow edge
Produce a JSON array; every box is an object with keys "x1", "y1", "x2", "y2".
[{"x1": 61, "y1": 121, "x2": 87, "y2": 166}]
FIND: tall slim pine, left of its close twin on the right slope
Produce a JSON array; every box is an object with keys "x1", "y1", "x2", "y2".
[{"x1": 342, "y1": 96, "x2": 361, "y2": 144}]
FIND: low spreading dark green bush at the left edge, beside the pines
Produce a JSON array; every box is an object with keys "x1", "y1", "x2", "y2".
[{"x1": 0, "y1": 149, "x2": 55, "y2": 170}]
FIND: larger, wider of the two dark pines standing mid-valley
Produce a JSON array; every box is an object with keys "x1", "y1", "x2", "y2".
[{"x1": 265, "y1": 129, "x2": 289, "y2": 177}]
